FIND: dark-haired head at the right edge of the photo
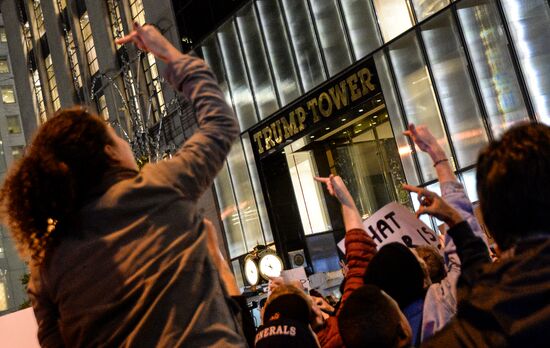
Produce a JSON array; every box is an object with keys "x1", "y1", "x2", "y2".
[{"x1": 476, "y1": 124, "x2": 550, "y2": 250}]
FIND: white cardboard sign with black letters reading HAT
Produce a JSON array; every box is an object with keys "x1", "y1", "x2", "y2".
[{"x1": 338, "y1": 202, "x2": 441, "y2": 253}]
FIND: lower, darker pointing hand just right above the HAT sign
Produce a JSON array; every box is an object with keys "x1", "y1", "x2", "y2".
[{"x1": 403, "y1": 184, "x2": 464, "y2": 227}]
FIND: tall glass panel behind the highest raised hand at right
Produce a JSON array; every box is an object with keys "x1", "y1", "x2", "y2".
[{"x1": 389, "y1": 33, "x2": 451, "y2": 181}]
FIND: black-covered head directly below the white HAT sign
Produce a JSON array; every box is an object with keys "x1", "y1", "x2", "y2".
[{"x1": 364, "y1": 243, "x2": 425, "y2": 308}]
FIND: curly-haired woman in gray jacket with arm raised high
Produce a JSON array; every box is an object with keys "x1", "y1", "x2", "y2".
[{"x1": 0, "y1": 25, "x2": 246, "y2": 347}]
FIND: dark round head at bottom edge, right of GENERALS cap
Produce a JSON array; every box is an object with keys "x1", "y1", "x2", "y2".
[{"x1": 338, "y1": 285, "x2": 402, "y2": 348}]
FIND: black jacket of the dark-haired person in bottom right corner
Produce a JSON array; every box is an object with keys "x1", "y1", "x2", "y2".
[{"x1": 422, "y1": 225, "x2": 550, "y2": 348}]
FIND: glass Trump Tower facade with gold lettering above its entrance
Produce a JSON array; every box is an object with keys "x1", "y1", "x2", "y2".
[{"x1": 183, "y1": 0, "x2": 550, "y2": 285}]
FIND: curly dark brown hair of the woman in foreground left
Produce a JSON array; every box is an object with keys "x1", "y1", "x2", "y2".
[{"x1": 0, "y1": 108, "x2": 113, "y2": 262}]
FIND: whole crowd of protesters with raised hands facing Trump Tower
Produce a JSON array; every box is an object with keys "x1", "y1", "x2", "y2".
[{"x1": 0, "y1": 25, "x2": 550, "y2": 348}]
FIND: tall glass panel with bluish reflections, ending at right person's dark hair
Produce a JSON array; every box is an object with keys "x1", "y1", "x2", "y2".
[{"x1": 457, "y1": 0, "x2": 528, "y2": 137}]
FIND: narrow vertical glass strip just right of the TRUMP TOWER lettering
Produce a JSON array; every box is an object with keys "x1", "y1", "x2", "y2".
[{"x1": 374, "y1": 52, "x2": 420, "y2": 185}]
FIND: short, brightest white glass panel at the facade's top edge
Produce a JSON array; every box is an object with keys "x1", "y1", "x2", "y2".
[{"x1": 374, "y1": 0, "x2": 413, "y2": 42}]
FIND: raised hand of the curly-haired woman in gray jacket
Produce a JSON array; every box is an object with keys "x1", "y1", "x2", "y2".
[{"x1": 115, "y1": 23, "x2": 183, "y2": 63}]
